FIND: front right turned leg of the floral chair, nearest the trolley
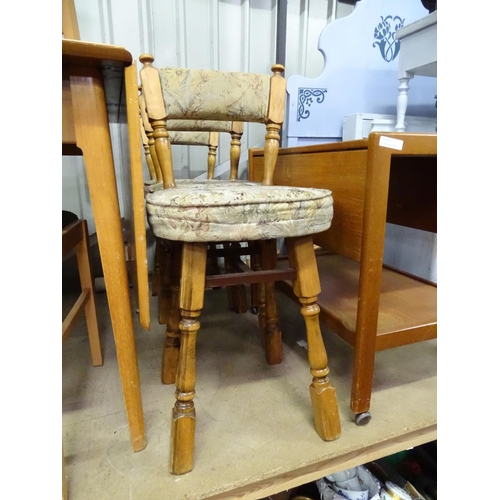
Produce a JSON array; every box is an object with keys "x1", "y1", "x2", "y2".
[{"x1": 286, "y1": 236, "x2": 340, "y2": 441}]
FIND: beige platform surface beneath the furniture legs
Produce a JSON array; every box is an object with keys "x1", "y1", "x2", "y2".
[{"x1": 62, "y1": 284, "x2": 437, "y2": 500}]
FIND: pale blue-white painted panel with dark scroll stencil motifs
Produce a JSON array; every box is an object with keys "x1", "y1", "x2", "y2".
[{"x1": 287, "y1": 0, "x2": 436, "y2": 145}]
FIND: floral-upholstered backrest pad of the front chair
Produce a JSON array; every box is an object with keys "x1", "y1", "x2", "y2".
[{"x1": 158, "y1": 68, "x2": 271, "y2": 123}]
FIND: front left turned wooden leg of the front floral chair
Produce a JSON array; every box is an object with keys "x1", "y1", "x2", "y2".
[{"x1": 170, "y1": 243, "x2": 207, "y2": 474}]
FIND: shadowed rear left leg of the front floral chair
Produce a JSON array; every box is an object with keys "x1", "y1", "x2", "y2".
[{"x1": 161, "y1": 241, "x2": 182, "y2": 384}]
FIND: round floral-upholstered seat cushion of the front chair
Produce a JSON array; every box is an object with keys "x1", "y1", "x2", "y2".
[{"x1": 146, "y1": 181, "x2": 333, "y2": 242}]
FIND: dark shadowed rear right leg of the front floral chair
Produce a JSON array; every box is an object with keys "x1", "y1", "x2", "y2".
[{"x1": 260, "y1": 240, "x2": 283, "y2": 365}]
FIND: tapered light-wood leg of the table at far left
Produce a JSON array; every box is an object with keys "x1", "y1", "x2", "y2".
[{"x1": 68, "y1": 66, "x2": 146, "y2": 451}]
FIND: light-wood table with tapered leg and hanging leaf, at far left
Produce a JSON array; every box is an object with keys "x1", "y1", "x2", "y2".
[{"x1": 62, "y1": 39, "x2": 149, "y2": 451}]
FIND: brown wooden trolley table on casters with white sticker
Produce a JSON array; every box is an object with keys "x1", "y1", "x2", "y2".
[{"x1": 248, "y1": 132, "x2": 437, "y2": 425}]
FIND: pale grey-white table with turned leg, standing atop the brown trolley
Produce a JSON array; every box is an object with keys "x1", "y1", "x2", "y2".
[{"x1": 395, "y1": 10, "x2": 437, "y2": 132}]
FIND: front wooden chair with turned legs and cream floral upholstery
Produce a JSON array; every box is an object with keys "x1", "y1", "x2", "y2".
[{"x1": 139, "y1": 55, "x2": 340, "y2": 474}]
